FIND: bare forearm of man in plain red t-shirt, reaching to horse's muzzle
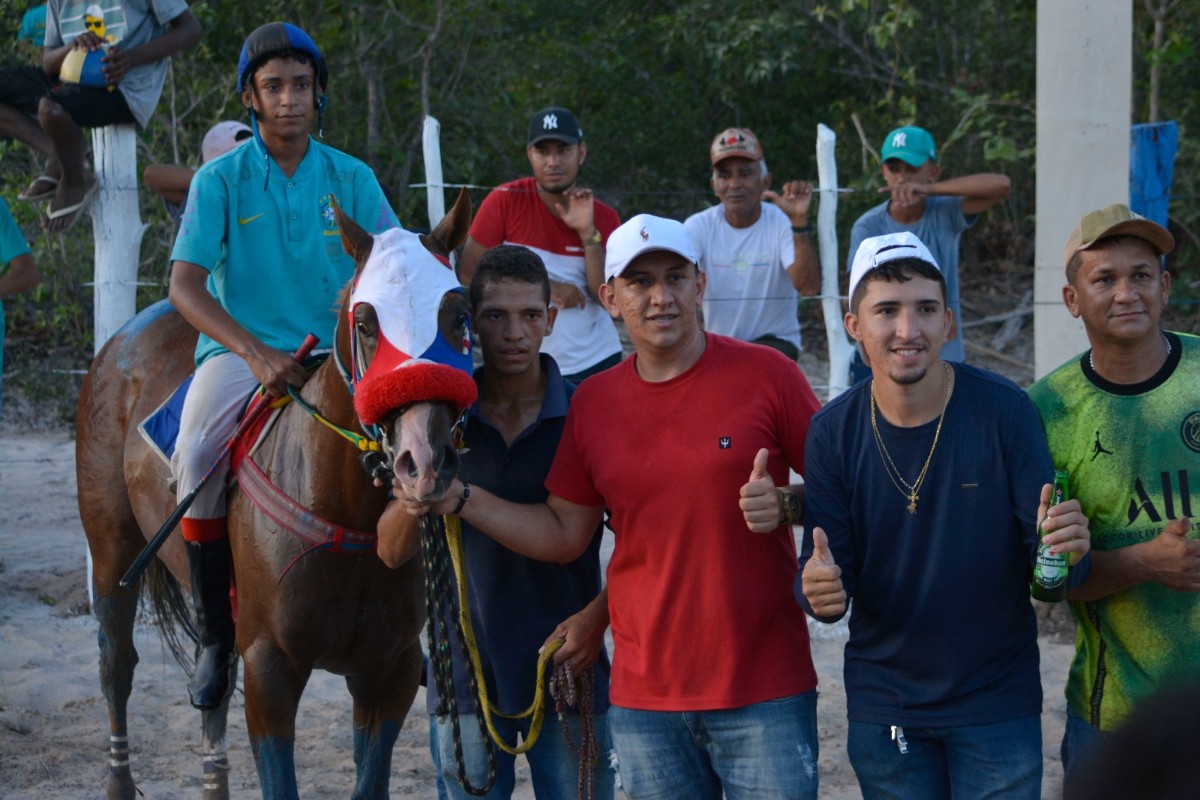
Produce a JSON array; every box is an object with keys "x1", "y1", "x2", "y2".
[{"x1": 396, "y1": 479, "x2": 604, "y2": 564}]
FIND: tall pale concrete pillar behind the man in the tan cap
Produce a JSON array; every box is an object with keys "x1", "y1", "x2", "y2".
[{"x1": 1033, "y1": 0, "x2": 1133, "y2": 378}]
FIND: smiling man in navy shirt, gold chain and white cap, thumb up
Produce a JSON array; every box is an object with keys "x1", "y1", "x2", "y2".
[{"x1": 742, "y1": 227, "x2": 1091, "y2": 800}]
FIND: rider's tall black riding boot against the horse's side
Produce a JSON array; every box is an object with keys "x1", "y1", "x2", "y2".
[{"x1": 185, "y1": 539, "x2": 236, "y2": 711}]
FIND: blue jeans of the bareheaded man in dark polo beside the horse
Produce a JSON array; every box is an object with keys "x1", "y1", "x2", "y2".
[{"x1": 430, "y1": 710, "x2": 613, "y2": 800}]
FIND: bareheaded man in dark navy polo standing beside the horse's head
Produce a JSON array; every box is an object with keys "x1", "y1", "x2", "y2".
[{"x1": 379, "y1": 245, "x2": 613, "y2": 799}]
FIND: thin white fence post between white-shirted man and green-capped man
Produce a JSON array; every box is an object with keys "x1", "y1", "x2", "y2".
[{"x1": 817, "y1": 124, "x2": 854, "y2": 401}]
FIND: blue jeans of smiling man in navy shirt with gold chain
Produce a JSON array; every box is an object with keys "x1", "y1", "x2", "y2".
[{"x1": 846, "y1": 716, "x2": 1042, "y2": 800}]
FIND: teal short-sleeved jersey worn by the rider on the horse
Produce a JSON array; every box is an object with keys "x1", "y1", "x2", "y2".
[{"x1": 172, "y1": 139, "x2": 400, "y2": 363}]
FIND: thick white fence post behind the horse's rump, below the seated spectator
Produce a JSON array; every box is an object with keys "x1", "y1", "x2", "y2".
[{"x1": 88, "y1": 125, "x2": 145, "y2": 607}]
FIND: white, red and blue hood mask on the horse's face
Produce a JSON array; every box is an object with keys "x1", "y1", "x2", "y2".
[{"x1": 349, "y1": 228, "x2": 478, "y2": 425}]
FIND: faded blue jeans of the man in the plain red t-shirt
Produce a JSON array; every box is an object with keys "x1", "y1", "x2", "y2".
[{"x1": 608, "y1": 690, "x2": 817, "y2": 800}]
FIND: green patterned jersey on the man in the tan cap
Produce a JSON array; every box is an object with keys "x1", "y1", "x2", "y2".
[{"x1": 1030, "y1": 333, "x2": 1200, "y2": 730}]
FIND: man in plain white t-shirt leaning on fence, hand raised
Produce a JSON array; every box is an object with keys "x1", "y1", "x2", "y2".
[{"x1": 684, "y1": 128, "x2": 821, "y2": 361}]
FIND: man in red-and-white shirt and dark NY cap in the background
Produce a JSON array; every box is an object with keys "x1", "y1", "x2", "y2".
[{"x1": 458, "y1": 108, "x2": 622, "y2": 384}]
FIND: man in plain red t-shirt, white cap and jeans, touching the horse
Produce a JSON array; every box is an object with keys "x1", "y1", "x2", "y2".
[{"x1": 406, "y1": 215, "x2": 820, "y2": 800}]
